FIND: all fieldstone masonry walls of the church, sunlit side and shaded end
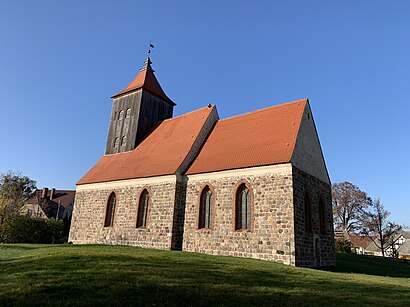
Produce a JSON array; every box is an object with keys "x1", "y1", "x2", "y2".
[{"x1": 70, "y1": 163, "x2": 335, "y2": 266}]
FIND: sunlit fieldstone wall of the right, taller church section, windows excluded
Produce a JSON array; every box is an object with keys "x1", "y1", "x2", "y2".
[{"x1": 183, "y1": 164, "x2": 295, "y2": 265}]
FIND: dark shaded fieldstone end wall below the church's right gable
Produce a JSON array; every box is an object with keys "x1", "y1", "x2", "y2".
[{"x1": 293, "y1": 167, "x2": 336, "y2": 267}]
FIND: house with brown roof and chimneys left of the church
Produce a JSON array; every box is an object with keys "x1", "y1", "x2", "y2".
[{"x1": 20, "y1": 188, "x2": 75, "y2": 221}]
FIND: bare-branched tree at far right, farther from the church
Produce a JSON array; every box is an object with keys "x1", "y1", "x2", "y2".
[{"x1": 360, "y1": 199, "x2": 403, "y2": 257}]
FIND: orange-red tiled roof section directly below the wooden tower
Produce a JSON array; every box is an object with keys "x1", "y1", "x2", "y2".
[{"x1": 77, "y1": 106, "x2": 215, "y2": 184}]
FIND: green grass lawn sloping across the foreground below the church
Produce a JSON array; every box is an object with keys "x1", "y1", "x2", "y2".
[{"x1": 0, "y1": 244, "x2": 410, "y2": 306}]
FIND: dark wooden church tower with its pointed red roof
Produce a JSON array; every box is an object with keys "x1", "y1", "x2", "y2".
[{"x1": 105, "y1": 57, "x2": 175, "y2": 155}]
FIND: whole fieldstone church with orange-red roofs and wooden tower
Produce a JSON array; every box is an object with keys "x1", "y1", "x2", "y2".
[{"x1": 69, "y1": 58, "x2": 336, "y2": 267}]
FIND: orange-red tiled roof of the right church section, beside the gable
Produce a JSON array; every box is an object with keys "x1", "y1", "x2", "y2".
[{"x1": 186, "y1": 99, "x2": 308, "y2": 174}]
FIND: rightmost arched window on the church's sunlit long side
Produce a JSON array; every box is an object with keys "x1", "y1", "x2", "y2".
[{"x1": 235, "y1": 183, "x2": 252, "y2": 230}]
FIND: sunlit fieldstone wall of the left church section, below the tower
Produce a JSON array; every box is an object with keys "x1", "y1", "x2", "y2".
[{"x1": 69, "y1": 175, "x2": 176, "y2": 249}]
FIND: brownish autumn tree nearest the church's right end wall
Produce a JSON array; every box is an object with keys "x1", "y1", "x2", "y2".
[{"x1": 332, "y1": 181, "x2": 372, "y2": 234}]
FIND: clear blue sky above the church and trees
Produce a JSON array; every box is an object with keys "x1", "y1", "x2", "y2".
[{"x1": 0, "y1": 0, "x2": 410, "y2": 226}]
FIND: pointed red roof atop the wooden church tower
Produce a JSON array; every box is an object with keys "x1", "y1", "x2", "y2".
[{"x1": 111, "y1": 58, "x2": 175, "y2": 105}]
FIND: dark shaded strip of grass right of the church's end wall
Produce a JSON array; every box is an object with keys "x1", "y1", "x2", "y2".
[{"x1": 321, "y1": 254, "x2": 410, "y2": 278}]
